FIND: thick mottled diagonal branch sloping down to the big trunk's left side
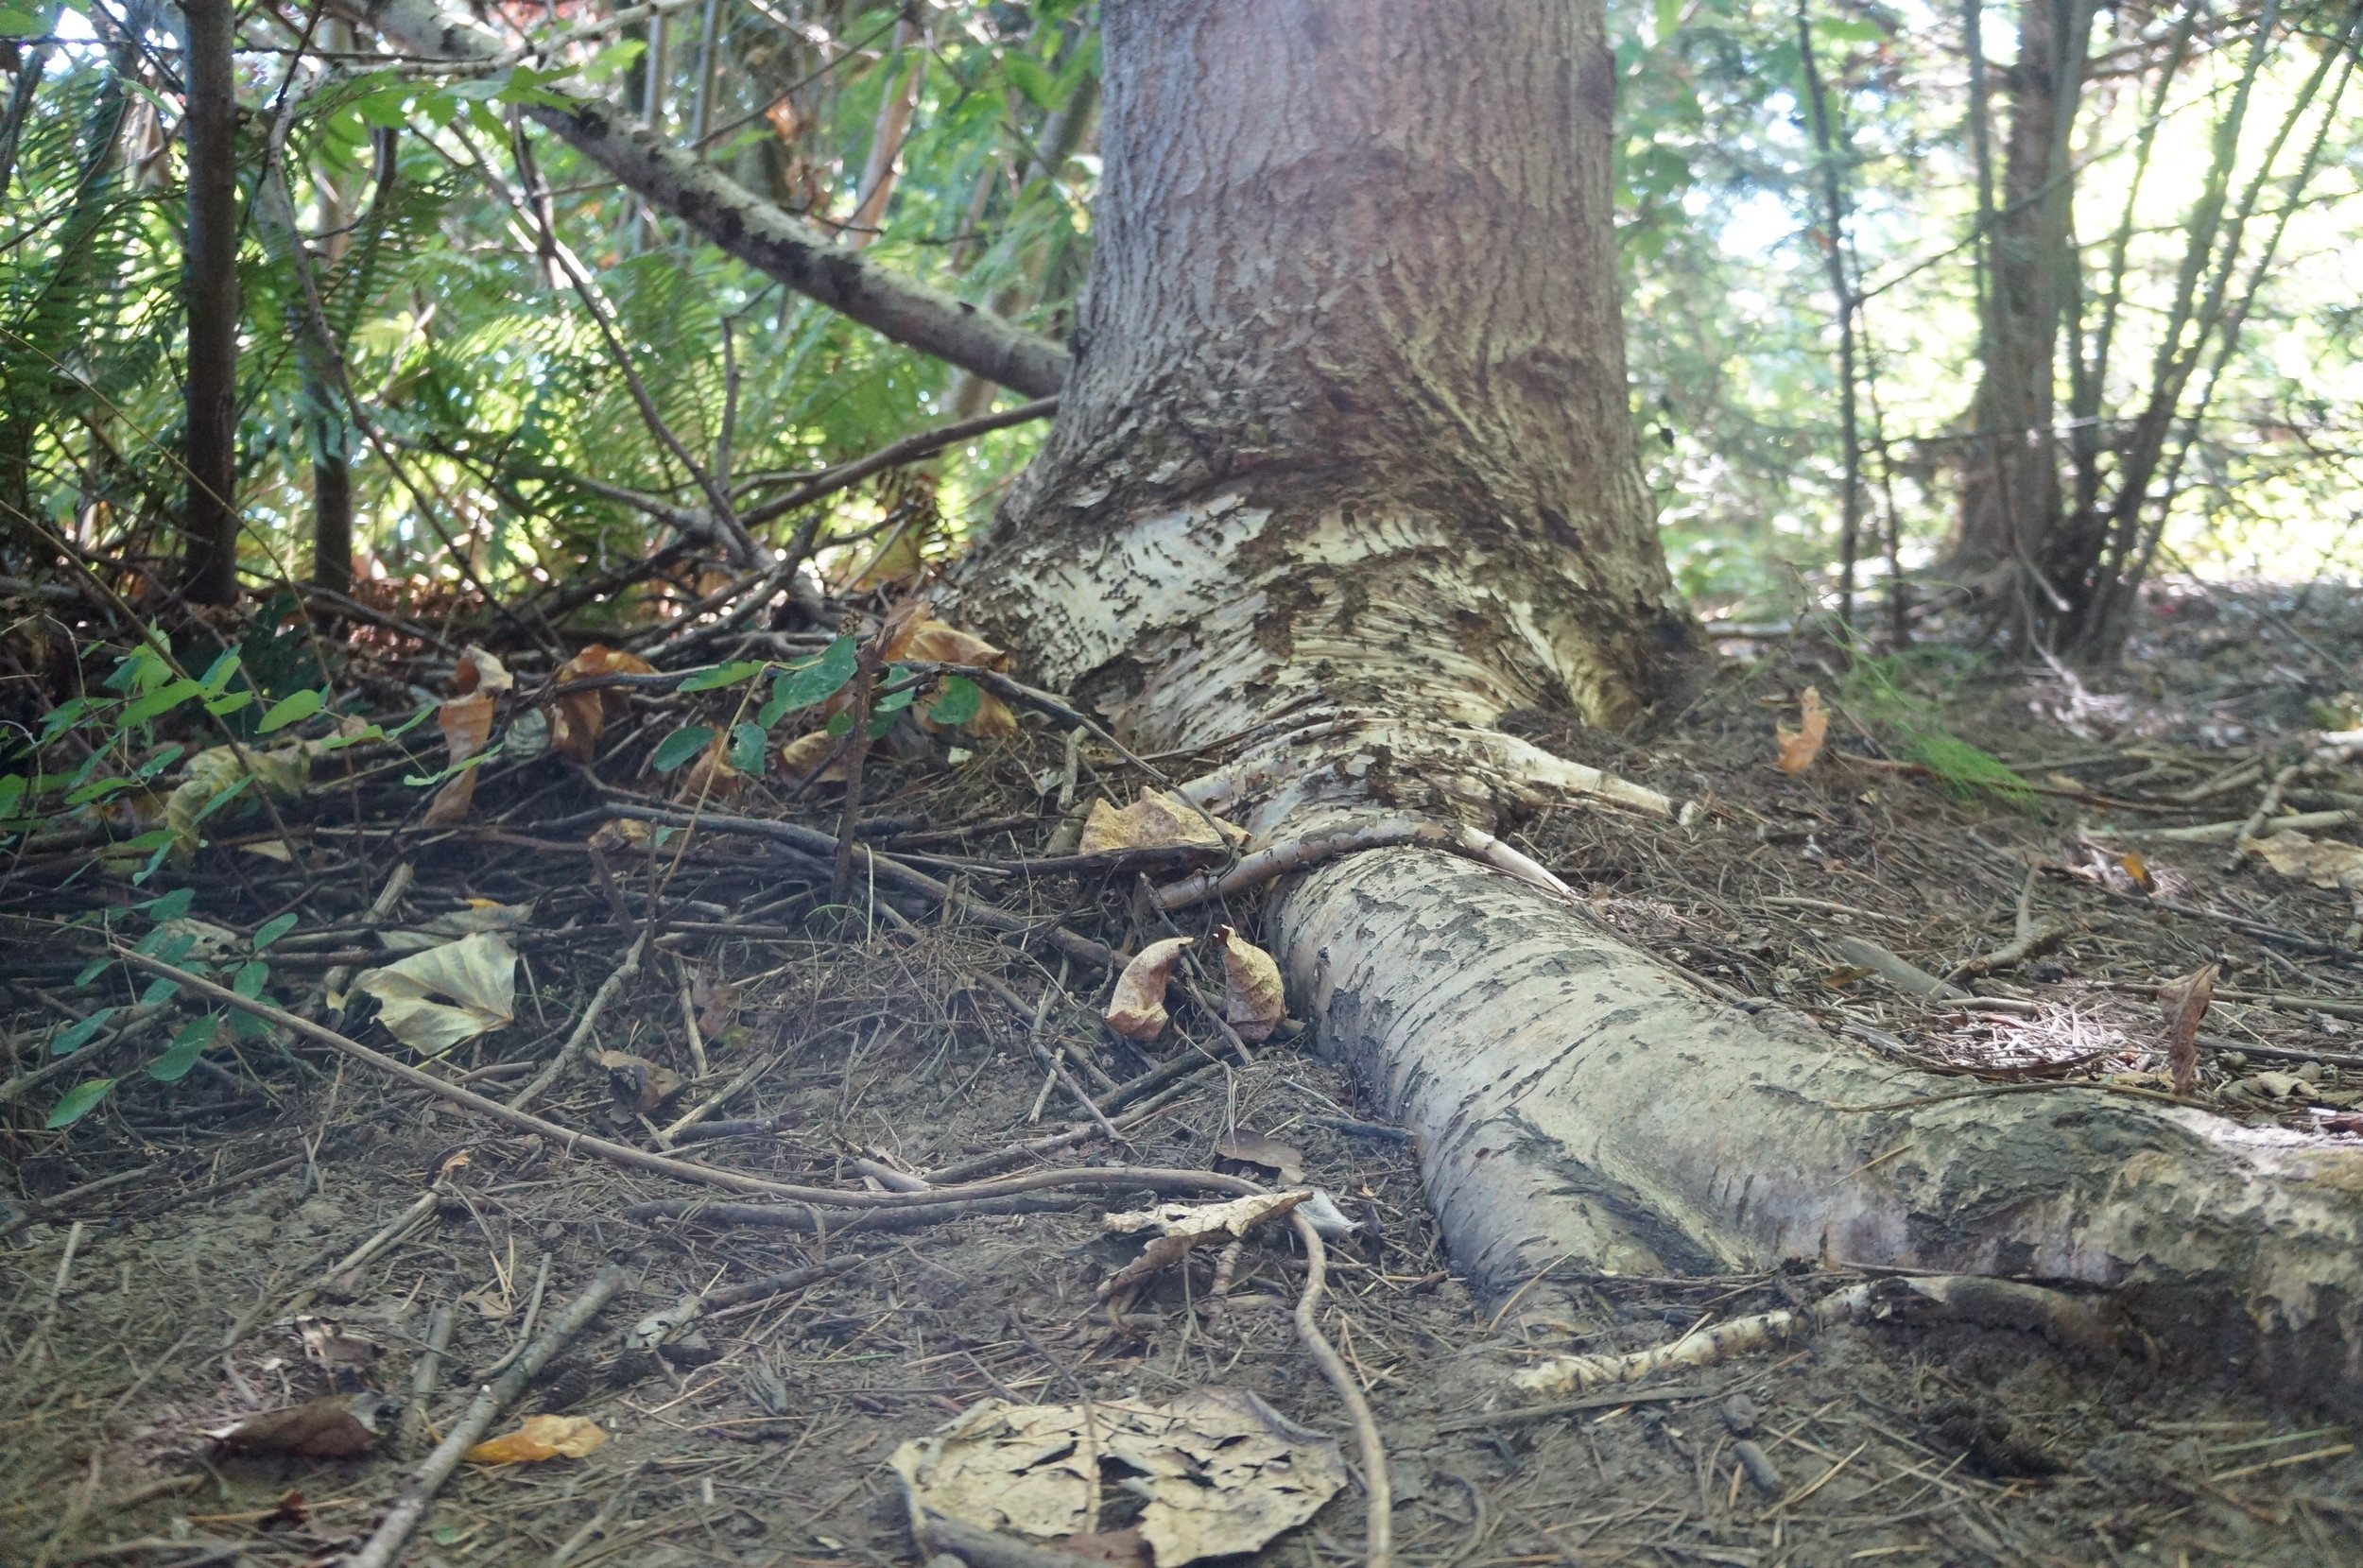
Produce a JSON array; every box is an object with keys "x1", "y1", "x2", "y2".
[{"x1": 348, "y1": 0, "x2": 1068, "y2": 397}]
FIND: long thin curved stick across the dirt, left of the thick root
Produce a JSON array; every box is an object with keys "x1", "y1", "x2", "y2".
[{"x1": 118, "y1": 949, "x2": 1267, "y2": 1209}]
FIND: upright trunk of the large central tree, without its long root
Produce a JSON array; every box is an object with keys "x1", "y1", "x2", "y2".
[{"x1": 962, "y1": 0, "x2": 1692, "y2": 755}]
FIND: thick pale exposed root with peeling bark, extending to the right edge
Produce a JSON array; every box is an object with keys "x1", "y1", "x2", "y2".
[{"x1": 1276, "y1": 850, "x2": 2363, "y2": 1415}]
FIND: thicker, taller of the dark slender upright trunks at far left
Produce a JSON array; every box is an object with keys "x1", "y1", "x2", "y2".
[{"x1": 182, "y1": 0, "x2": 239, "y2": 605}]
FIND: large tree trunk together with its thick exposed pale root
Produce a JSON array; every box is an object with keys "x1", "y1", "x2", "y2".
[{"x1": 936, "y1": 0, "x2": 2363, "y2": 1410}]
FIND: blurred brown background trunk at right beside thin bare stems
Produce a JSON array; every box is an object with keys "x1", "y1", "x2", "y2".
[{"x1": 1952, "y1": 0, "x2": 2094, "y2": 572}]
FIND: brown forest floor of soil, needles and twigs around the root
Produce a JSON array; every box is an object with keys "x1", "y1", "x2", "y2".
[{"x1": 0, "y1": 583, "x2": 2363, "y2": 1568}]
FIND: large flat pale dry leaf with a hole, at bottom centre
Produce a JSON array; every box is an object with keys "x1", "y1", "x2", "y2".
[{"x1": 888, "y1": 1388, "x2": 1347, "y2": 1568}]
